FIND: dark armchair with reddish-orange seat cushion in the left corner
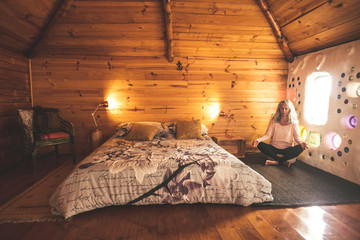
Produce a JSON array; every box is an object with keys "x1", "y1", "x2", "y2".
[{"x1": 18, "y1": 107, "x2": 76, "y2": 173}]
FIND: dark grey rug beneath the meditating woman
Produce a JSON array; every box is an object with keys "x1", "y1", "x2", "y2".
[{"x1": 241, "y1": 153, "x2": 360, "y2": 207}]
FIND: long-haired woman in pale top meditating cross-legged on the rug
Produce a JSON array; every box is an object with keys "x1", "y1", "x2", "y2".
[{"x1": 253, "y1": 100, "x2": 308, "y2": 167}]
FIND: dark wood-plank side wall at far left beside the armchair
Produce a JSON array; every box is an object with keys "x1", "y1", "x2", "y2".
[{"x1": 0, "y1": 48, "x2": 31, "y2": 170}]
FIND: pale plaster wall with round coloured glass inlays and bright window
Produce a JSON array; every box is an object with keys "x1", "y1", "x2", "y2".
[{"x1": 287, "y1": 40, "x2": 360, "y2": 184}]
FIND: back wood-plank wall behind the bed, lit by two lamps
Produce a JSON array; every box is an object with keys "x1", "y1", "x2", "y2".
[{"x1": 32, "y1": 55, "x2": 287, "y2": 156}]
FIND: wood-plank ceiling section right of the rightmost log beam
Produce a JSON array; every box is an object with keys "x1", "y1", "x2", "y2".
[{"x1": 267, "y1": 0, "x2": 360, "y2": 56}]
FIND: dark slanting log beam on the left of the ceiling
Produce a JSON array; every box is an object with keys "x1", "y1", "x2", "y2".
[{"x1": 26, "y1": 0, "x2": 74, "y2": 58}]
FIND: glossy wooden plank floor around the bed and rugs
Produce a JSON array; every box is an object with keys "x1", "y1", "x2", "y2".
[{"x1": 0, "y1": 157, "x2": 360, "y2": 240}]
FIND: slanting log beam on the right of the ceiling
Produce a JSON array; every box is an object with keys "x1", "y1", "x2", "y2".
[{"x1": 257, "y1": 0, "x2": 294, "y2": 62}]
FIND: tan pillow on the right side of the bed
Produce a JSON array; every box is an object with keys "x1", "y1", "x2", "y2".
[{"x1": 176, "y1": 120, "x2": 203, "y2": 139}]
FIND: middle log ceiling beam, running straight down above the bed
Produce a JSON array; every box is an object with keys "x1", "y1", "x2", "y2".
[{"x1": 162, "y1": 0, "x2": 174, "y2": 62}]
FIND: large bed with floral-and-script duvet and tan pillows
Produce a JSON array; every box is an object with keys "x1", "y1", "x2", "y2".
[{"x1": 49, "y1": 121, "x2": 273, "y2": 218}]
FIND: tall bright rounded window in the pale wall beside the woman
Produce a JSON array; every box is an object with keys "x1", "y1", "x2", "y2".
[{"x1": 304, "y1": 72, "x2": 332, "y2": 125}]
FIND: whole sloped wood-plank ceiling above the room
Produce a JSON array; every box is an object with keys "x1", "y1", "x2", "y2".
[{"x1": 0, "y1": 0, "x2": 360, "y2": 60}]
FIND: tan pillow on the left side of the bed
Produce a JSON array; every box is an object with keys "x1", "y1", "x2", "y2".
[{"x1": 125, "y1": 123, "x2": 159, "y2": 141}]
